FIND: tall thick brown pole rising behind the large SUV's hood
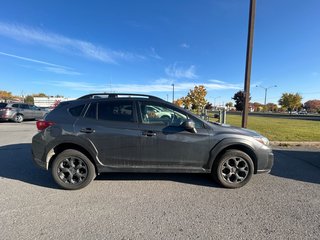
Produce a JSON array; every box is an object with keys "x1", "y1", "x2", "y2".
[{"x1": 241, "y1": 0, "x2": 256, "y2": 128}]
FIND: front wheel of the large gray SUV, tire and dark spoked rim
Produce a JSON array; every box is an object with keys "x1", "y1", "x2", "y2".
[{"x1": 212, "y1": 149, "x2": 254, "y2": 188}]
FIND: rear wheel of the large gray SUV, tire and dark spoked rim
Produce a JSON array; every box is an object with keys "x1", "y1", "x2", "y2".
[{"x1": 51, "y1": 149, "x2": 96, "y2": 190}]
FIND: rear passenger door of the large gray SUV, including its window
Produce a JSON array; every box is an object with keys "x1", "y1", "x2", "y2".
[{"x1": 75, "y1": 100, "x2": 141, "y2": 167}]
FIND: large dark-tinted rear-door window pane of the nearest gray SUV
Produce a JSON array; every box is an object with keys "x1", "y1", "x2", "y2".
[{"x1": 98, "y1": 101, "x2": 133, "y2": 122}]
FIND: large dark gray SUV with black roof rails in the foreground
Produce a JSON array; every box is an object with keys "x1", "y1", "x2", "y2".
[{"x1": 32, "y1": 94, "x2": 273, "y2": 190}]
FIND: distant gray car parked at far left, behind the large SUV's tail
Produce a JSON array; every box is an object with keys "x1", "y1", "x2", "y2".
[{"x1": 0, "y1": 103, "x2": 48, "y2": 123}]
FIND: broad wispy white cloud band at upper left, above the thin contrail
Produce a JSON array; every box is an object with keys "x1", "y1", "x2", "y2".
[{"x1": 0, "y1": 22, "x2": 143, "y2": 63}]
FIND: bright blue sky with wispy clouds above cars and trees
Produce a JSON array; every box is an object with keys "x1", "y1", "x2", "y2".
[{"x1": 0, "y1": 0, "x2": 320, "y2": 104}]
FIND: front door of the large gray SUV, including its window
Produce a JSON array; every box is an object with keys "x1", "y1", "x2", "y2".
[{"x1": 138, "y1": 101, "x2": 212, "y2": 167}]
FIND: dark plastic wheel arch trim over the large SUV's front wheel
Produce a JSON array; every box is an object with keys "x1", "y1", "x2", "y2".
[{"x1": 209, "y1": 141, "x2": 258, "y2": 174}]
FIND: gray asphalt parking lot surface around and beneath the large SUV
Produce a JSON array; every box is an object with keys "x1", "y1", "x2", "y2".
[{"x1": 0, "y1": 121, "x2": 320, "y2": 239}]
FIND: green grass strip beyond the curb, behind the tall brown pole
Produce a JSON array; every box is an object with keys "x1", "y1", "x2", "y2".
[{"x1": 222, "y1": 114, "x2": 320, "y2": 142}]
